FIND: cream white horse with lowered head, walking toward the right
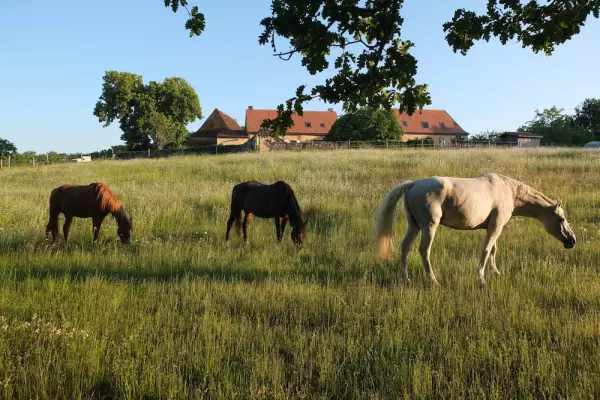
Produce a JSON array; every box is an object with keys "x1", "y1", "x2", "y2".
[{"x1": 375, "y1": 173, "x2": 575, "y2": 285}]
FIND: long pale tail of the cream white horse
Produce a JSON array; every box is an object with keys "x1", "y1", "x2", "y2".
[{"x1": 375, "y1": 181, "x2": 414, "y2": 260}]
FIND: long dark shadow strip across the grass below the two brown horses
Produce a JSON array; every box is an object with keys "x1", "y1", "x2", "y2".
[{"x1": 0, "y1": 245, "x2": 418, "y2": 288}]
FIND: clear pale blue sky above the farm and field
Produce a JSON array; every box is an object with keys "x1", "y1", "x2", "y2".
[{"x1": 0, "y1": 0, "x2": 600, "y2": 152}]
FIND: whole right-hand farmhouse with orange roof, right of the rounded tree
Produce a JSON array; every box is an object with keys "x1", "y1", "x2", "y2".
[{"x1": 394, "y1": 108, "x2": 469, "y2": 146}]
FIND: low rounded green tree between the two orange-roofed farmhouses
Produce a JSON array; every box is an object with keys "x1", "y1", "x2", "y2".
[{"x1": 326, "y1": 108, "x2": 404, "y2": 141}]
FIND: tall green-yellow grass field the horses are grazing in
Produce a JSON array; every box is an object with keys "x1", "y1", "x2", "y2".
[{"x1": 0, "y1": 149, "x2": 600, "y2": 399}]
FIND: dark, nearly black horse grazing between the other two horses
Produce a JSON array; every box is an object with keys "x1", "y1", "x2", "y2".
[{"x1": 225, "y1": 181, "x2": 307, "y2": 247}]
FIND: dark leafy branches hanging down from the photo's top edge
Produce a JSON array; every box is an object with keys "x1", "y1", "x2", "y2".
[{"x1": 164, "y1": 0, "x2": 600, "y2": 134}]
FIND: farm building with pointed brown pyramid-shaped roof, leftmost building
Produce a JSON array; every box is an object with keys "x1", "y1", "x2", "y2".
[{"x1": 188, "y1": 108, "x2": 250, "y2": 146}]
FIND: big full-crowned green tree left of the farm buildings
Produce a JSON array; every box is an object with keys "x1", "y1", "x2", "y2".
[{"x1": 94, "y1": 71, "x2": 202, "y2": 150}]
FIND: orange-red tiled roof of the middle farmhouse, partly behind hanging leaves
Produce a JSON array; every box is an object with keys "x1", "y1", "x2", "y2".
[{"x1": 246, "y1": 107, "x2": 337, "y2": 136}]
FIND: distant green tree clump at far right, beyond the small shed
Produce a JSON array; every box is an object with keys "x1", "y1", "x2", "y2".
[{"x1": 518, "y1": 107, "x2": 593, "y2": 145}]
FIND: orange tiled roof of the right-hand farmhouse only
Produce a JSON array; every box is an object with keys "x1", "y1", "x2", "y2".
[{"x1": 394, "y1": 108, "x2": 468, "y2": 136}]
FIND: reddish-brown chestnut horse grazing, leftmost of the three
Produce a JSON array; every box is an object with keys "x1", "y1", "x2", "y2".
[{"x1": 46, "y1": 182, "x2": 132, "y2": 243}]
